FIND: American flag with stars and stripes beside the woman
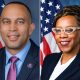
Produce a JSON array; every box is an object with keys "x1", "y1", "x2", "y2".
[{"x1": 40, "y1": 0, "x2": 62, "y2": 65}]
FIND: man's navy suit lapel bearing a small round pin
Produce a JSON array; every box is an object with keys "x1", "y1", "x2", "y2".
[{"x1": 17, "y1": 40, "x2": 38, "y2": 80}]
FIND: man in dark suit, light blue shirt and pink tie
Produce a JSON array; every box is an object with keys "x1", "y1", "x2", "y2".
[{"x1": 0, "y1": 2, "x2": 39, "y2": 80}]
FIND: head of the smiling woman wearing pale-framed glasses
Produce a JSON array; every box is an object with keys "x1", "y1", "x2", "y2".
[{"x1": 53, "y1": 6, "x2": 80, "y2": 53}]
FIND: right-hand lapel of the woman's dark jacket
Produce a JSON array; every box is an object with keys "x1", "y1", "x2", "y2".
[{"x1": 56, "y1": 53, "x2": 80, "y2": 80}]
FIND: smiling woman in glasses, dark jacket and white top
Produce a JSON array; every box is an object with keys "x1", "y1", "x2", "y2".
[{"x1": 41, "y1": 6, "x2": 80, "y2": 80}]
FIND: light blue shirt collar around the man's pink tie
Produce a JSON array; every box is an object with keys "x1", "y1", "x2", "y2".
[{"x1": 6, "y1": 40, "x2": 31, "y2": 64}]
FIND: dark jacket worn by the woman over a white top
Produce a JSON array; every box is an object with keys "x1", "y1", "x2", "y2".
[{"x1": 41, "y1": 52, "x2": 80, "y2": 80}]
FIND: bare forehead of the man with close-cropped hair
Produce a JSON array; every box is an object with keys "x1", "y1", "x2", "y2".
[{"x1": 1, "y1": 4, "x2": 29, "y2": 16}]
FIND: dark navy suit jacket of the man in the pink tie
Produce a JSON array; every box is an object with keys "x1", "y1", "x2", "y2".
[{"x1": 0, "y1": 41, "x2": 39, "y2": 80}]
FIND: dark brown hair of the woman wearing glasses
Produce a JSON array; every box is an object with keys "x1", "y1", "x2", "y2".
[{"x1": 53, "y1": 5, "x2": 80, "y2": 27}]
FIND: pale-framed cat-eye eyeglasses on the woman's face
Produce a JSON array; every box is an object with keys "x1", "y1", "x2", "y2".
[{"x1": 52, "y1": 27, "x2": 80, "y2": 35}]
